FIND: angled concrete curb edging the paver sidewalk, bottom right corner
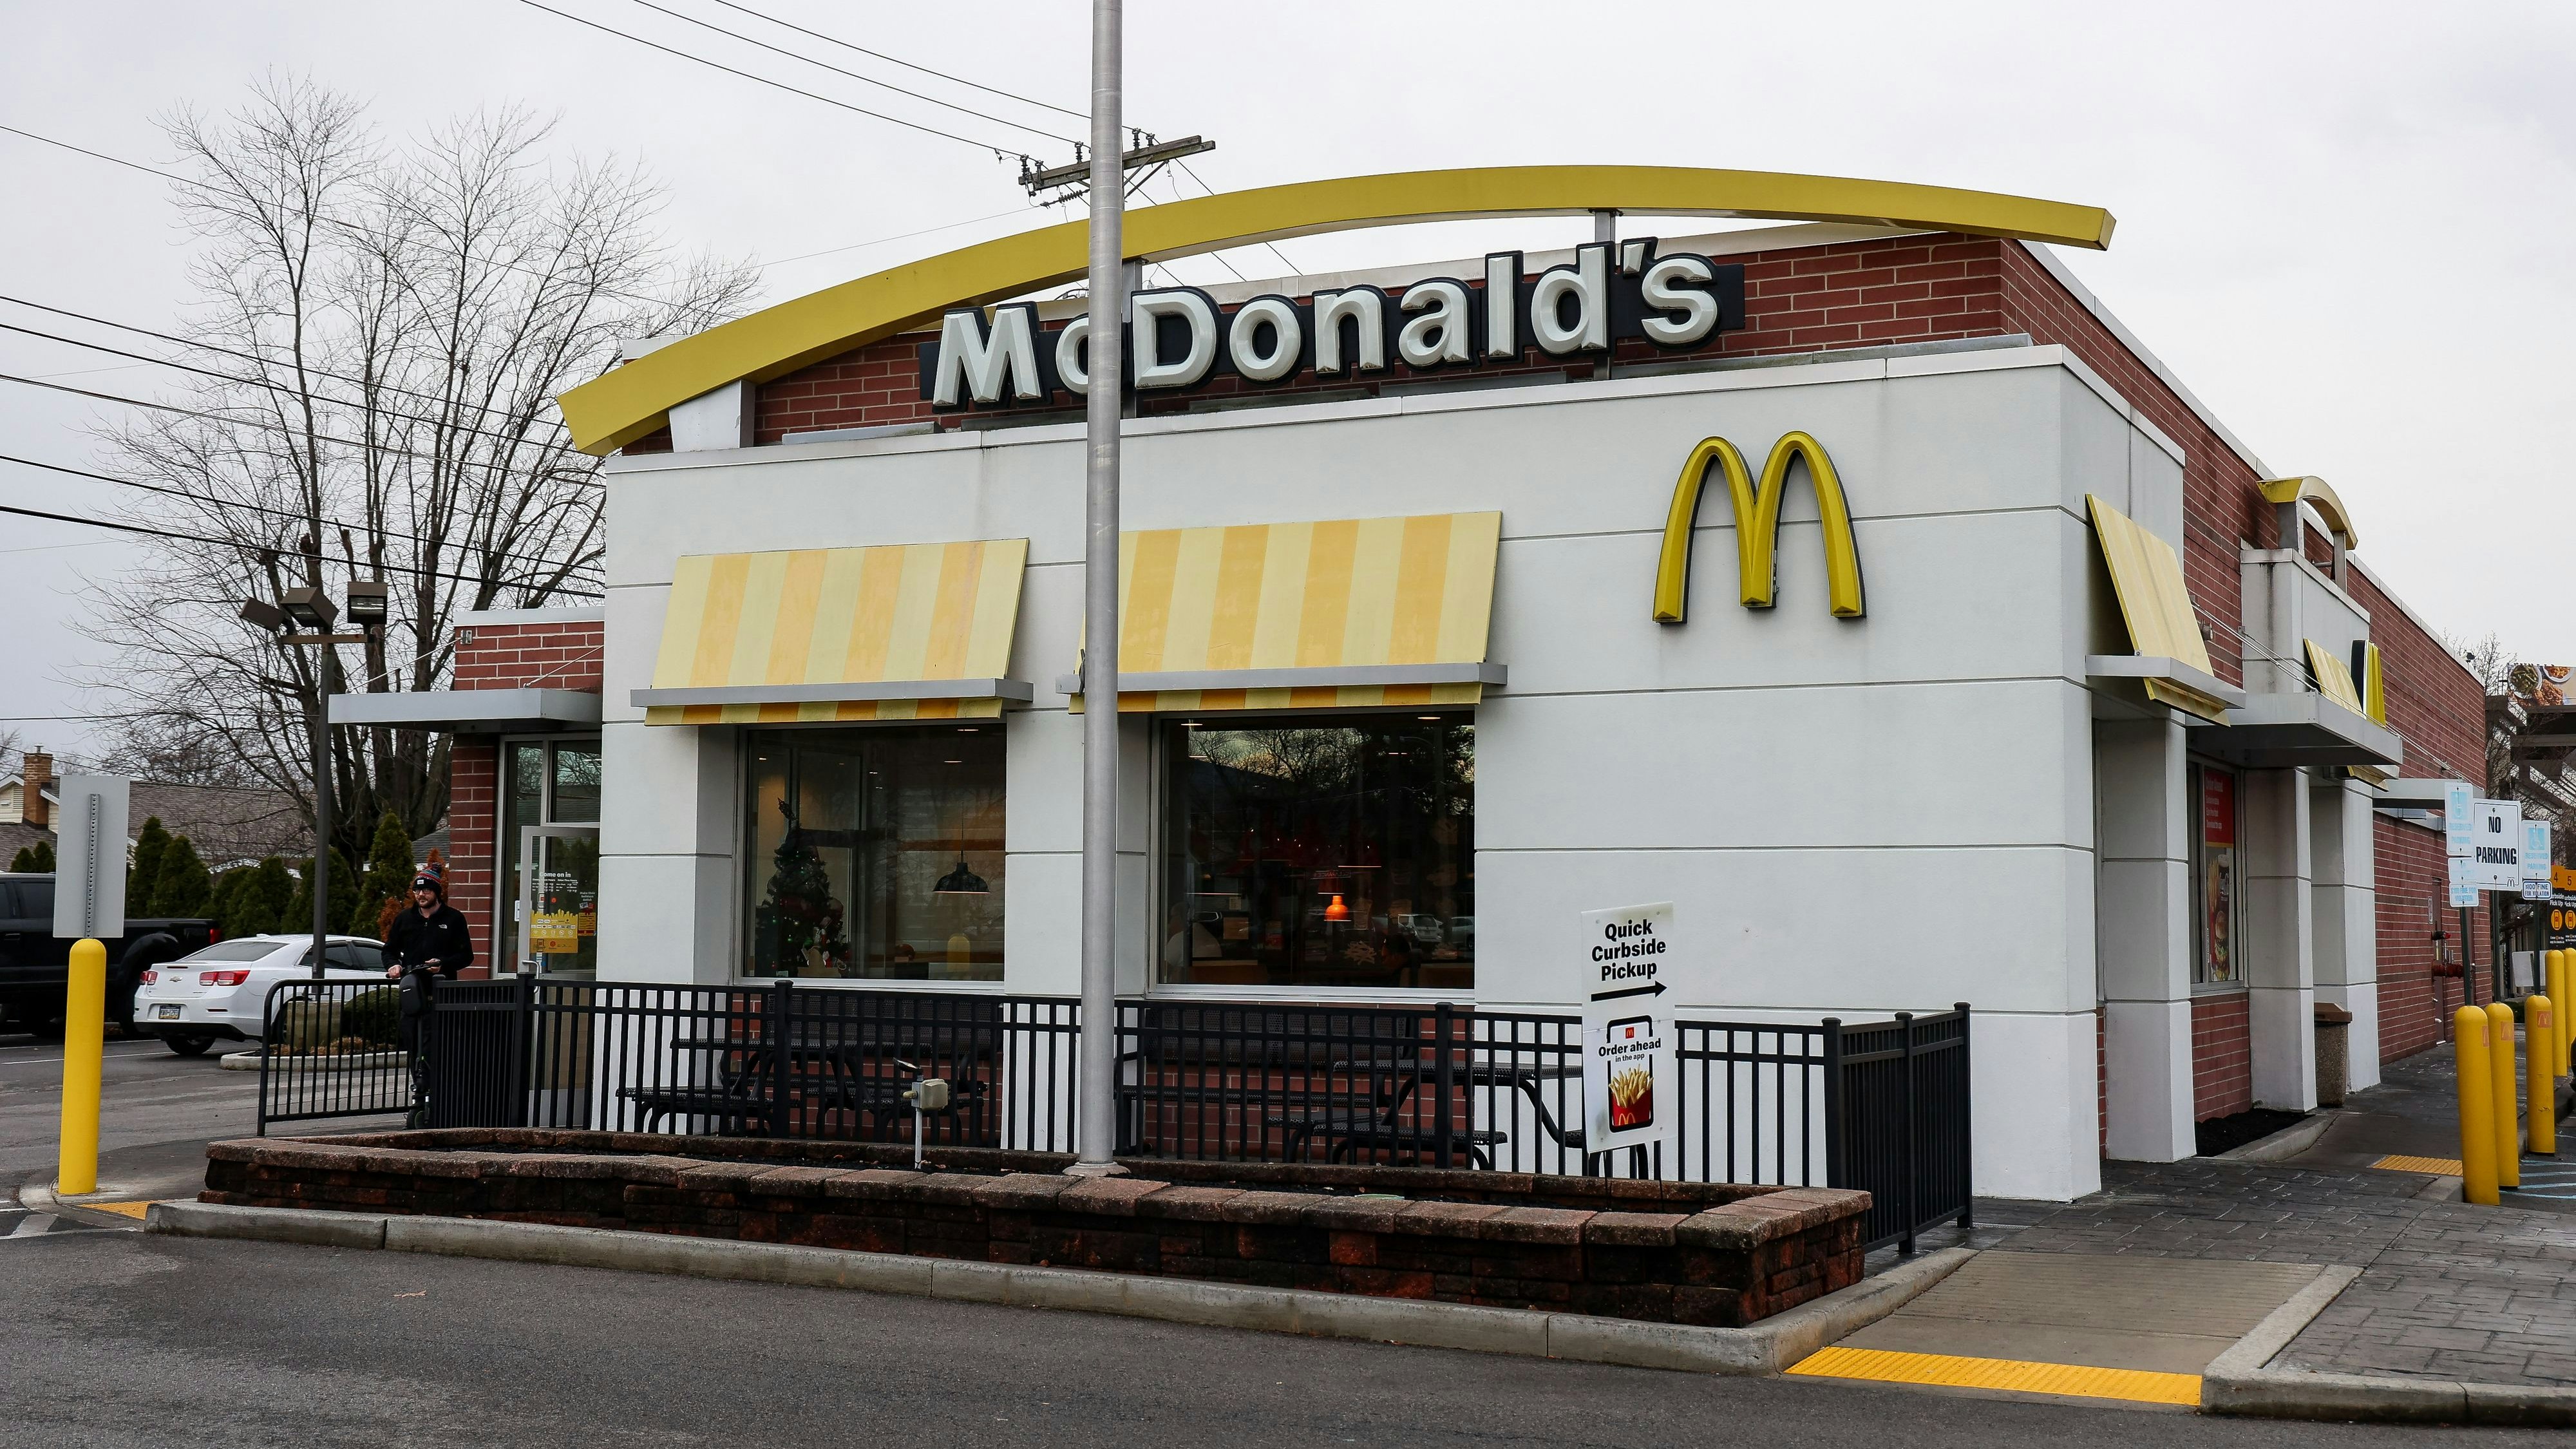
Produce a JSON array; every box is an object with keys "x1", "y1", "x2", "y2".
[{"x1": 2200, "y1": 1266, "x2": 2576, "y2": 1428}]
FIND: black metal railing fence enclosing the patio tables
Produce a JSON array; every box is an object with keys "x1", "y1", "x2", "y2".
[{"x1": 260, "y1": 980, "x2": 1971, "y2": 1251}]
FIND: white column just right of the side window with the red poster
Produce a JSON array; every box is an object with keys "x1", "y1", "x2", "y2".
[{"x1": 2241, "y1": 768, "x2": 2316, "y2": 1112}]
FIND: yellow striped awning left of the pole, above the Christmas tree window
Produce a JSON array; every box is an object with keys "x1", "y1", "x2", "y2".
[{"x1": 634, "y1": 539, "x2": 1030, "y2": 724}]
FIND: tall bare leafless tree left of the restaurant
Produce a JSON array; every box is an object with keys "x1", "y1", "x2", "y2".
[{"x1": 90, "y1": 80, "x2": 755, "y2": 856}]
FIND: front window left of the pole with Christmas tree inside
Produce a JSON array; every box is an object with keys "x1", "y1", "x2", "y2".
[{"x1": 742, "y1": 722, "x2": 1005, "y2": 982}]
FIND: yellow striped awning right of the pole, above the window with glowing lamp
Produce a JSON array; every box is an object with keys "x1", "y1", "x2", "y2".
[{"x1": 1059, "y1": 513, "x2": 1504, "y2": 712}]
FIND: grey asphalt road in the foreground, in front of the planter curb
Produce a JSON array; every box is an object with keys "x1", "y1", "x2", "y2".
[{"x1": 0, "y1": 1233, "x2": 2555, "y2": 1449}]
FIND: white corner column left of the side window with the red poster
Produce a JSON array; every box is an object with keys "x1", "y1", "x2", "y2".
[{"x1": 2094, "y1": 717, "x2": 2195, "y2": 1163}]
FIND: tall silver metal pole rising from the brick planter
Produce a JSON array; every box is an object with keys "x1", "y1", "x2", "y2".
[{"x1": 1069, "y1": 0, "x2": 1126, "y2": 1176}]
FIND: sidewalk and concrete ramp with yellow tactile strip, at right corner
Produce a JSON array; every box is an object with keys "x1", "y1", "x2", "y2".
[{"x1": 1801, "y1": 1031, "x2": 2576, "y2": 1423}]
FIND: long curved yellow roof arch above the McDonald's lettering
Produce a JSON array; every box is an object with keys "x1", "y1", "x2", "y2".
[{"x1": 559, "y1": 165, "x2": 2112, "y2": 454}]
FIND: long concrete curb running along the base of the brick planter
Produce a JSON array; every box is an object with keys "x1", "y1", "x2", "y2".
[{"x1": 144, "y1": 1202, "x2": 1976, "y2": 1374}]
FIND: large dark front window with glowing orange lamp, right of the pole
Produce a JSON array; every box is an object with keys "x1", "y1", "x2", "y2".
[{"x1": 1157, "y1": 714, "x2": 1476, "y2": 987}]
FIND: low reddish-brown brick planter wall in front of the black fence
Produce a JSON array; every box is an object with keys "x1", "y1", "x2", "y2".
[{"x1": 204, "y1": 1130, "x2": 1870, "y2": 1325}]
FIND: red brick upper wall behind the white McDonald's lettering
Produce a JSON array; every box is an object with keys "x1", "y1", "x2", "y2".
[{"x1": 747, "y1": 237, "x2": 2009, "y2": 451}]
